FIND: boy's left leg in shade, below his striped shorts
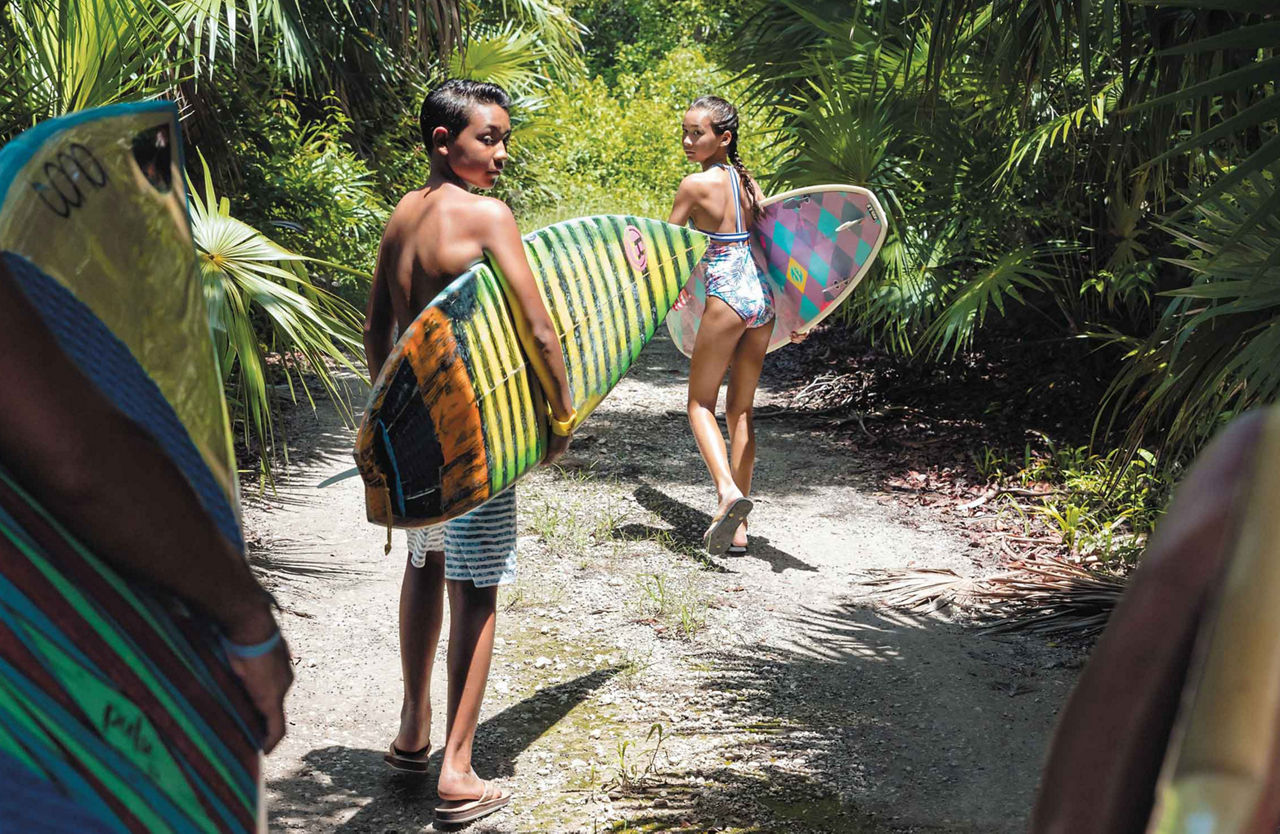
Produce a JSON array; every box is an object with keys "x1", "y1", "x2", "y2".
[{"x1": 393, "y1": 531, "x2": 444, "y2": 753}]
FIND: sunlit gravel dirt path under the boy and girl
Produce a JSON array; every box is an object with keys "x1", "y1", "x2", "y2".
[{"x1": 246, "y1": 338, "x2": 1075, "y2": 833}]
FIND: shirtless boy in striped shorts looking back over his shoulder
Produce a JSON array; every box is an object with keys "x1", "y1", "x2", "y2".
[{"x1": 365, "y1": 81, "x2": 573, "y2": 824}]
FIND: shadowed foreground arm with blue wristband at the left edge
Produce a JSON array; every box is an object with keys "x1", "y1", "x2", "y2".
[{"x1": 0, "y1": 262, "x2": 293, "y2": 751}]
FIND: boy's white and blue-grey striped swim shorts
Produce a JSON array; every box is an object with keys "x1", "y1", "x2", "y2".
[{"x1": 408, "y1": 487, "x2": 516, "y2": 588}]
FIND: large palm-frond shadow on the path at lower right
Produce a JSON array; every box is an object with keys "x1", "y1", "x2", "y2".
[{"x1": 704, "y1": 600, "x2": 1071, "y2": 834}]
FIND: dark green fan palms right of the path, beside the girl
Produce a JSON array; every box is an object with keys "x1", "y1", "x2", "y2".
[{"x1": 726, "y1": 0, "x2": 1280, "y2": 463}]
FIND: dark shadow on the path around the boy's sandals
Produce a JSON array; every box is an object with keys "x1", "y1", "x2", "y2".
[{"x1": 269, "y1": 666, "x2": 621, "y2": 834}]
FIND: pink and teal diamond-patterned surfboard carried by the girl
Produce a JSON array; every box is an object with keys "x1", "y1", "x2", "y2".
[{"x1": 667, "y1": 185, "x2": 888, "y2": 356}]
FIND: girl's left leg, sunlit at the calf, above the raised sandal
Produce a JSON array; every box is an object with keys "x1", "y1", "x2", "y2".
[{"x1": 689, "y1": 297, "x2": 746, "y2": 507}]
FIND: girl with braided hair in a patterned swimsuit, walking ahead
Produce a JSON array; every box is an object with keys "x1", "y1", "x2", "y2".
[{"x1": 671, "y1": 96, "x2": 798, "y2": 556}]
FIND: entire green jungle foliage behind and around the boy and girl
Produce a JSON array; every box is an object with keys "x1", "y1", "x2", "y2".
[{"x1": 0, "y1": 0, "x2": 1280, "y2": 475}]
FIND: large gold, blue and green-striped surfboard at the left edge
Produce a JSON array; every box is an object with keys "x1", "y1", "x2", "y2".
[{"x1": 0, "y1": 102, "x2": 262, "y2": 834}]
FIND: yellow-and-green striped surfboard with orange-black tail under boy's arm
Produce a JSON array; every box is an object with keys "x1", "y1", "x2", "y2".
[{"x1": 356, "y1": 215, "x2": 707, "y2": 527}]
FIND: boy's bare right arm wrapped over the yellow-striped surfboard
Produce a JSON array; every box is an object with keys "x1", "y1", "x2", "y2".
[{"x1": 483, "y1": 200, "x2": 573, "y2": 432}]
